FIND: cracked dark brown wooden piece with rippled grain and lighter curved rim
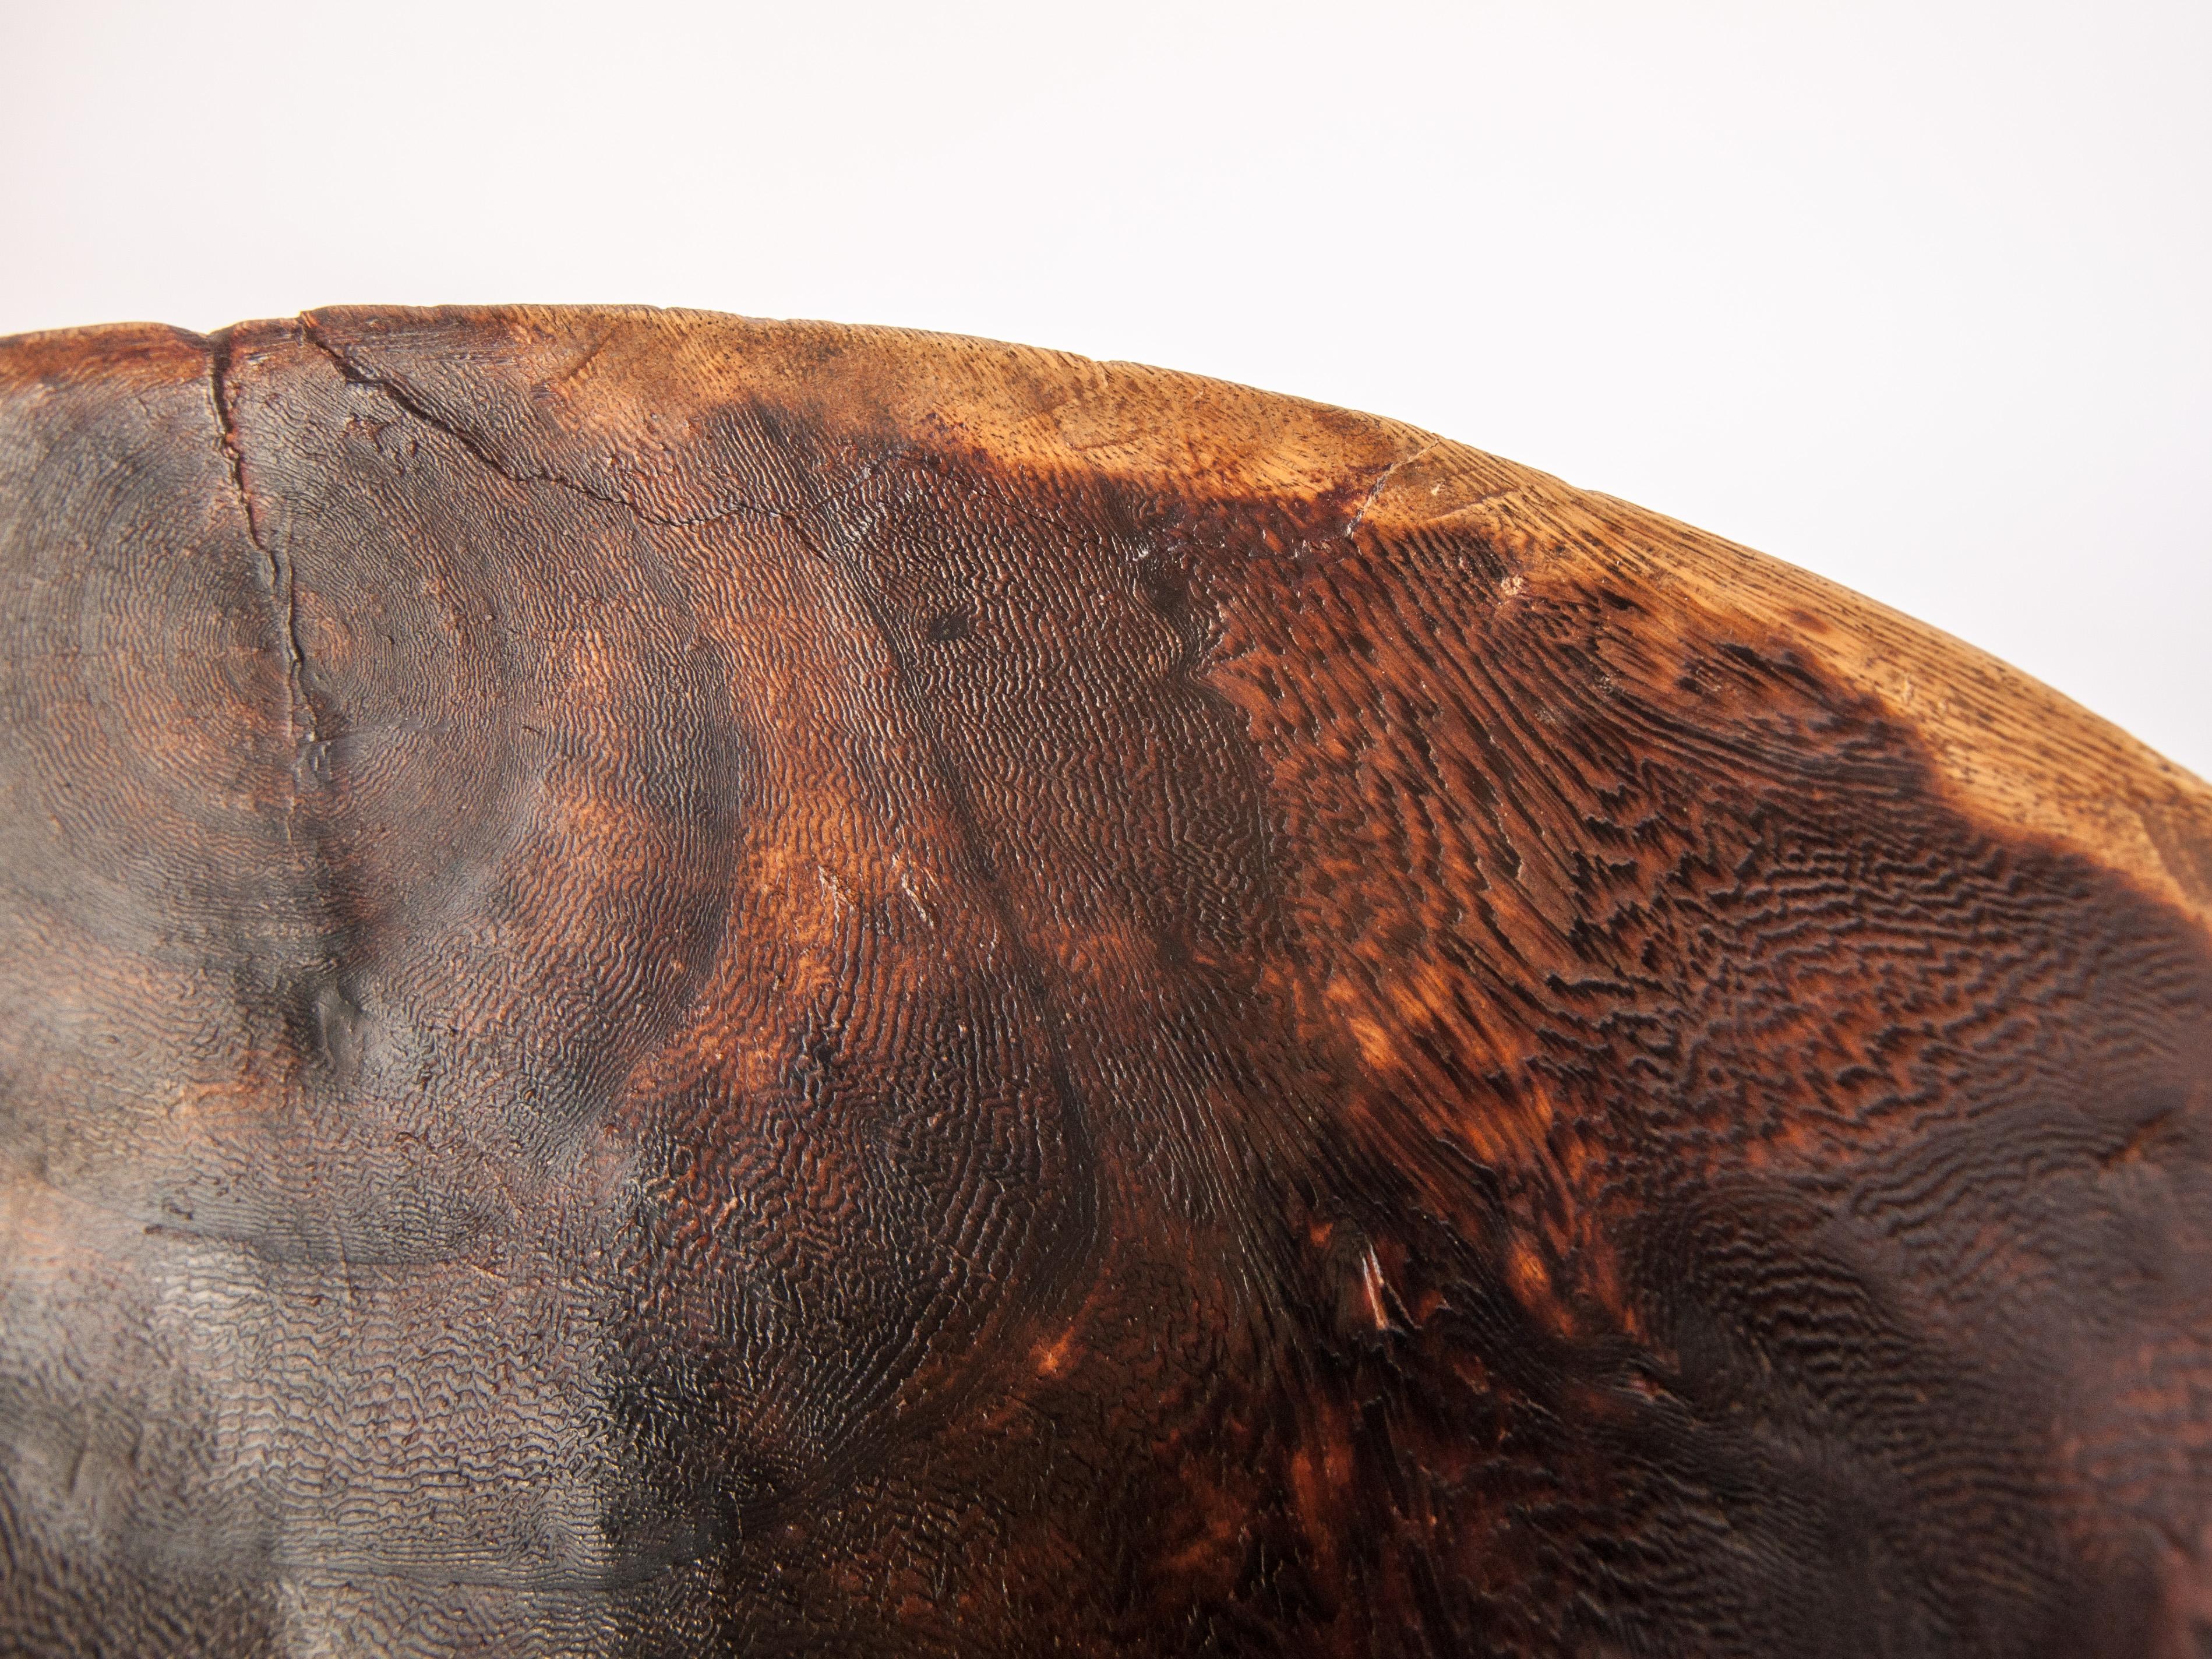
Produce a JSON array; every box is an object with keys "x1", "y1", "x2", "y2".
[{"x1": 13, "y1": 310, "x2": 2212, "y2": 1659}]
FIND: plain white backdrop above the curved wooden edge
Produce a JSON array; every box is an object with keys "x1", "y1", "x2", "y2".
[{"x1": 0, "y1": 0, "x2": 2212, "y2": 774}]
